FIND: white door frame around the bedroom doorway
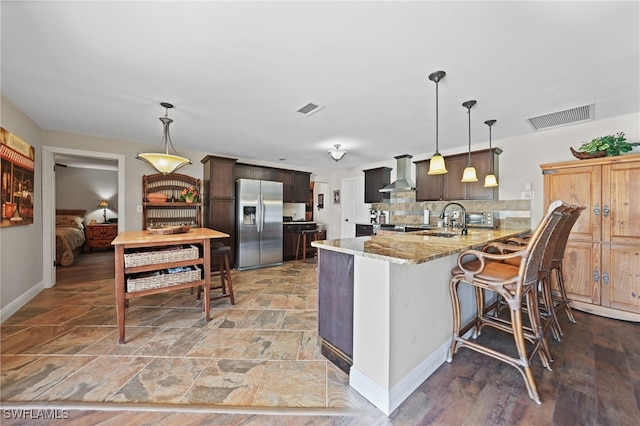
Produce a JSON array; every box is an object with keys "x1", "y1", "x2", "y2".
[{"x1": 42, "y1": 146, "x2": 126, "y2": 288}]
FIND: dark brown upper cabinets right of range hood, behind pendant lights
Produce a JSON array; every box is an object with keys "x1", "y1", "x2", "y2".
[{"x1": 414, "y1": 148, "x2": 502, "y2": 201}]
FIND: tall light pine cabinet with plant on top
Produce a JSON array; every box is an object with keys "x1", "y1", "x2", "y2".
[{"x1": 541, "y1": 155, "x2": 640, "y2": 321}]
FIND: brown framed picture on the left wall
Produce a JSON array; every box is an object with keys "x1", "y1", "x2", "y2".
[{"x1": 0, "y1": 127, "x2": 36, "y2": 227}]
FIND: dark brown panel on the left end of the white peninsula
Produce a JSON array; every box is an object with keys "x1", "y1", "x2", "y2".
[{"x1": 318, "y1": 250, "x2": 353, "y2": 374}]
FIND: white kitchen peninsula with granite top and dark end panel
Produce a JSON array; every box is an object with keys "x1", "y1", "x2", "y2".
[{"x1": 312, "y1": 228, "x2": 529, "y2": 415}]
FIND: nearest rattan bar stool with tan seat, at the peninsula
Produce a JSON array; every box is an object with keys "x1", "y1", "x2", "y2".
[{"x1": 447, "y1": 200, "x2": 569, "y2": 404}]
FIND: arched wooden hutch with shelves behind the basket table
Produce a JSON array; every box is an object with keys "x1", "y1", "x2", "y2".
[{"x1": 142, "y1": 173, "x2": 202, "y2": 230}]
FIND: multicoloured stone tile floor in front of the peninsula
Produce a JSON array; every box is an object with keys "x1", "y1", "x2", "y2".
[{"x1": 0, "y1": 260, "x2": 380, "y2": 413}]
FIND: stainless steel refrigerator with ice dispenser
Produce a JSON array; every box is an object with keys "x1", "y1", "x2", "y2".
[{"x1": 236, "y1": 179, "x2": 282, "y2": 271}]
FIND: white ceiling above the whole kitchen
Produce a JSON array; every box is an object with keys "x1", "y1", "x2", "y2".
[{"x1": 1, "y1": 0, "x2": 640, "y2": 170}]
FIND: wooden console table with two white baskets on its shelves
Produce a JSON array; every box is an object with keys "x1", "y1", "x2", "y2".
[{"x1": 111, "y1": 228, "x2": 229, "y2": 343}]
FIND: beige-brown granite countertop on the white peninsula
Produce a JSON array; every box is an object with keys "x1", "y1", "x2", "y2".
[{"x1": 311, "y1": 228, "x2": 530, "y2": 265}]
